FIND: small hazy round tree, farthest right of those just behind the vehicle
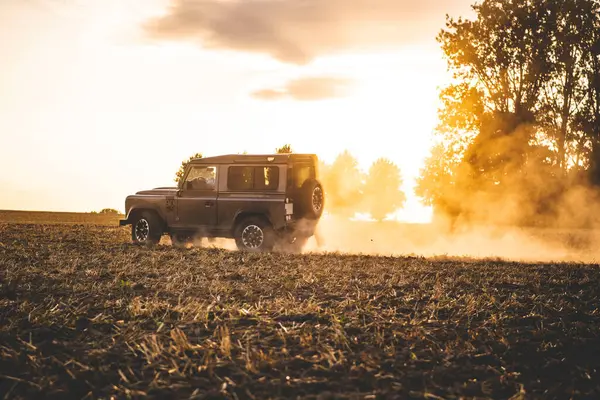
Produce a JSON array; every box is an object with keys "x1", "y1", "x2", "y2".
[{"x1": 364, "y1": 158, "x2": 406, "y2": 221}]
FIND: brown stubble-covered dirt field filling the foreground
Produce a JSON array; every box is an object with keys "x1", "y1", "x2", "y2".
[{"x1": 0, "y1": 214, "x2": 600, "y2": 399}]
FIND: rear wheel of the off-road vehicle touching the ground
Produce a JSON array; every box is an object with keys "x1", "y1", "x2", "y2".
[{"x1": 234, "y1": 216, "x2": 275, "y2": 253}]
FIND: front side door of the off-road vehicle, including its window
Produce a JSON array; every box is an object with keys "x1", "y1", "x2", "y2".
[{"x1": 177, "y1": 165, "x2": 218, "y2": 228}]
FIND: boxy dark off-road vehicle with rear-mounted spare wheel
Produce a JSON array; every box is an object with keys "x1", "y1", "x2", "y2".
[{"x1": 119, "y1": 154, "x2": 325, "y2": 252}]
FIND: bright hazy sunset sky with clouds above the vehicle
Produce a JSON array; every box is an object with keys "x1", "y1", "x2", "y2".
[{"x1": 0, "y1": 0, "x2": 472, "y2": 221}]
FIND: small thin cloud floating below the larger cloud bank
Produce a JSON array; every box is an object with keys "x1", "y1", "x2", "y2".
[{"x1": 251, "y1": 77, "x2": 352, "y2": 101}]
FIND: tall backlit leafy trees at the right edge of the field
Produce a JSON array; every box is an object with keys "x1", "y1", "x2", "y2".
[{"x1": 416, "y1": 0, "x2": 600, "y2": 225}]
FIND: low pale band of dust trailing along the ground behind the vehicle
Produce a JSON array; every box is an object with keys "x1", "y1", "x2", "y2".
[{"x1": 305, "y1": 218, "x2": 600, "y2": 262}]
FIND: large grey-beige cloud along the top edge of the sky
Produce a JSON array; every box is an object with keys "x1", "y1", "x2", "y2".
[{"x1": 143, "y1": 0, "x2": 470, "y2": 65}]
